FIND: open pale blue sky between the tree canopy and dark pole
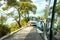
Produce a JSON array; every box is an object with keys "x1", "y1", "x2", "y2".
[{"x1": 32, "y1": 0, "x2": 54, "y2": 17}]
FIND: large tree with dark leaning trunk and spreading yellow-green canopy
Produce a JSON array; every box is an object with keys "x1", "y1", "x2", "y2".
[{"x1": 3, "y1": 0, "x2": 36, "y2": 27}]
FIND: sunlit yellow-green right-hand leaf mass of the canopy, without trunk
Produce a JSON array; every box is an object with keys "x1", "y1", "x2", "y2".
[{"x1": 17, "y1": 2, "x2": 36, "y2": 13}]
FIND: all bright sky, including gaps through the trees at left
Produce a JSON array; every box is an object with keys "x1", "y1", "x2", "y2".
[{"x1": 0, "y1": 0, "x2": 54, "y2": 23}]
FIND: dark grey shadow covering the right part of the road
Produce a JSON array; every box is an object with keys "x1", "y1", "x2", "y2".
[{"x1": 24, "y1": 28, "x2": 42, "y2": 40}]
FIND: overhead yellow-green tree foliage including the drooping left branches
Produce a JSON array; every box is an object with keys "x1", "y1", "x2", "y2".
[{"x1": 3, "y1": 0, "x2": 36, "y2": 26}]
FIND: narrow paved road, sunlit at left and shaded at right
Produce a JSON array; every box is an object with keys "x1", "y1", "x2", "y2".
[{"x1": 4, "y1": 27, "x2": 42, "y2": 40}]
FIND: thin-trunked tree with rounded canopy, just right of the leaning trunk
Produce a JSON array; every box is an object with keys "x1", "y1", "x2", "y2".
[{"x1": 17, "y1": 2, "x2": 36, "y2": 21}]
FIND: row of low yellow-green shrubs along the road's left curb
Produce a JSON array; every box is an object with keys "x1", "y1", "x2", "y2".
[{"x1": 0, "y1": 20, "x2": 28, "y2": 37}]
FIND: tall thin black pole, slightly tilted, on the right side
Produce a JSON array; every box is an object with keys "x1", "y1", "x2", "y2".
[{"x1": 50, "y1": 0, "x2": 57, "y2": 40}]
